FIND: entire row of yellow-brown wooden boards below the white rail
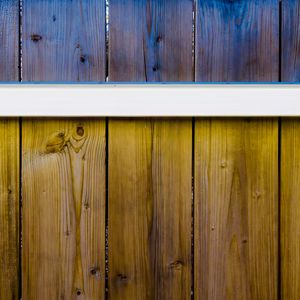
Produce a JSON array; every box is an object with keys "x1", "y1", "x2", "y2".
[{"x1": 0, "y1": 118, "x2": 300, "y2": 300}]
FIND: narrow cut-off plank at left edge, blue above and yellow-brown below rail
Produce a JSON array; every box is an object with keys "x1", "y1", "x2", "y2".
[{"x1": 0, "y1": 0, "x2": 20, "y2": 300}]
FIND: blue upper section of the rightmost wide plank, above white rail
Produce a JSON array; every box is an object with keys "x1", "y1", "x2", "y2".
[{"x1": 195, "y1": 0, "x2": 279, "y2": 81}]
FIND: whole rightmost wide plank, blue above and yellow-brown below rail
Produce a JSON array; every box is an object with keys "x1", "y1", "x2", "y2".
[{"x1": 194, "y1": 0, "x2": 279, "y2": 299}]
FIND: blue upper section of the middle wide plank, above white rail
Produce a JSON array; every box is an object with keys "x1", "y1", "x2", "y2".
[{"x1": 109, "y1": 0, "x2": 194, "y2": 81}]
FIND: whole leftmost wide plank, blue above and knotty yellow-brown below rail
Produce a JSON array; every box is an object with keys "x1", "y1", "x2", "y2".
[{"x1": 22, "y1": 0, "x2": 106, "y2": 299}]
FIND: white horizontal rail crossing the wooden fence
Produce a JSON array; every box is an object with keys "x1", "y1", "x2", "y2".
[{"x1": 0, "y1": 84, "x2": 300, "y2": 117}]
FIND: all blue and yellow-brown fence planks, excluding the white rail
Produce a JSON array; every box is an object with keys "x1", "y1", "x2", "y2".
[{"x1": 0, "y1": 0, "x2": 300, "y2": 300}]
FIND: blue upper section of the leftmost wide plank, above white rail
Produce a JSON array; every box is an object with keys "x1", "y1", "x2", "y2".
[{"x1": 22, "y1": 0, "x2": 105, "y2": 82}]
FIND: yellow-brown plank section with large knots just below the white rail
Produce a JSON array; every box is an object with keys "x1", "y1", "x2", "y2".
[{"x1": 22, "y1": 119, "x2": 106, "y2": 299}]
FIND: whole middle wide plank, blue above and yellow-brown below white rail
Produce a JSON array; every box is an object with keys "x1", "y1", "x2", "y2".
[{"x1": 108, "y1": 0, "x2": 193, "y2": 299}]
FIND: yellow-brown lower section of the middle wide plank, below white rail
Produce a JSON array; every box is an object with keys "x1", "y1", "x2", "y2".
[{"x1": 108, "y1": 120, "x2": 192, "y2": 299}]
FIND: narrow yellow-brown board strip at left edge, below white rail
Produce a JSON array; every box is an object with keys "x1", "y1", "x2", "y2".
[{"x1": 0, "y1": 120, "x2": 20, "y2": 300}]
